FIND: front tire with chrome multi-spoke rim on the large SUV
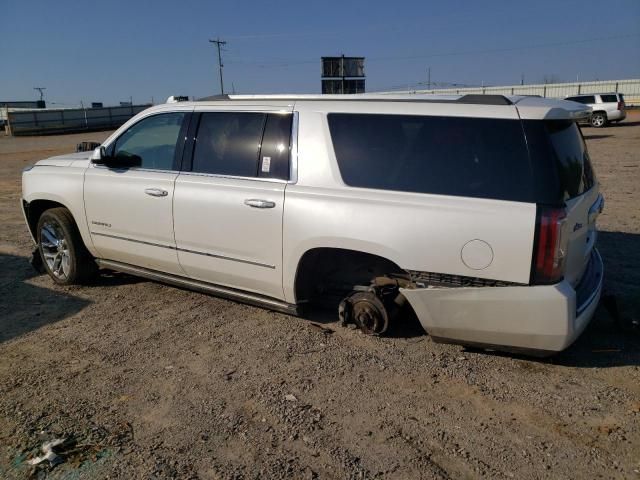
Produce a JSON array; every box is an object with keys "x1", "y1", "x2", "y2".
[{"x1": 37, "y1": 207, "x2": 98, "y2": 285}]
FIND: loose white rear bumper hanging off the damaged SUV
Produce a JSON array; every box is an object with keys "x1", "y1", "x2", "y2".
[{"x1": 401, "y1": 249, "x2": 604, "y2": 354}]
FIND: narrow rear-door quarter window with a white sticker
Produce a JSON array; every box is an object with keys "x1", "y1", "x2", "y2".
[{"x1": 258, "y1": 114, "x2": 293, "y2": 180}]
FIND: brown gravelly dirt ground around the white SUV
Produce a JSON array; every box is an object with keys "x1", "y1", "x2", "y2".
[{"x1": 0, "y1": 114, "x2": 640, "y2": 479}]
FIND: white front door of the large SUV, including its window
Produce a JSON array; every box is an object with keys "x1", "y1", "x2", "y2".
[{"x1": 84, "y1": 112, "x2": 189, "y2": 275}]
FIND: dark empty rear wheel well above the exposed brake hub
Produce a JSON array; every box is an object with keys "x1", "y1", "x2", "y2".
[{"x1": 295, "y1": 248, "x2": 406, "y2": 303}]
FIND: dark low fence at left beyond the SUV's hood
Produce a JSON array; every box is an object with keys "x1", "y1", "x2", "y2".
[{"x1": 5, "y1": 105, "x2": 150, "y2": 135}]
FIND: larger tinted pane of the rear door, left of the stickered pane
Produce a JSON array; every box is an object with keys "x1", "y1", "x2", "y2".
[{"x1": 192, "y1": 112, "x2": 266, "y2": 177}]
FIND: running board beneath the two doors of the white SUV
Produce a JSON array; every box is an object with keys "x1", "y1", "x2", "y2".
[{"x1": 96, "y1": 258, "x2": 300, "y2": 315}]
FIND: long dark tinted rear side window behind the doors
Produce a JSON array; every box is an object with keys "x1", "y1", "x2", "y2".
[{"x1": 328, "y1": 114, "x2": 534, "y2": 201}]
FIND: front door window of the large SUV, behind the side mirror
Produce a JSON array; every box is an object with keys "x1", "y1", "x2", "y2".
[{"x1": 113, "y1": 112, "x2": 186, "y2": 170}]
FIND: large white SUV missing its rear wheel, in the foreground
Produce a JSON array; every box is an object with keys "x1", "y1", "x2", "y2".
[{"x1": 22, "y1": 95, "x2": 603, "y2": 353}]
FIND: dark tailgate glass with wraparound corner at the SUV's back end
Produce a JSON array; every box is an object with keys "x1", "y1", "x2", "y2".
[{"x1": 523, "y1": 120, "x2": 595, "y2": 204}]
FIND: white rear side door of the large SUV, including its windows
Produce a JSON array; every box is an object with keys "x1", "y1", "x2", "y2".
[{"x1": 173, "y1": 107, "x2": 293, "y2": 299}]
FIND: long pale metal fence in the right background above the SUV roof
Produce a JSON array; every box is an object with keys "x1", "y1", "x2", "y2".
[{"x1": 385, "y1": 79, "x2": 640, "y2": 105}]
